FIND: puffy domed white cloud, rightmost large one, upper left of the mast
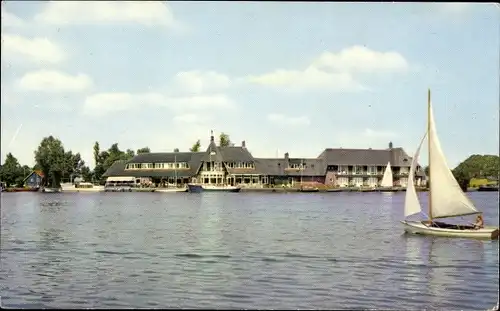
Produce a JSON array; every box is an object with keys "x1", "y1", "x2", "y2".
[{"x1": 313, "y1": 45, "x2": 409, "y2": 73}]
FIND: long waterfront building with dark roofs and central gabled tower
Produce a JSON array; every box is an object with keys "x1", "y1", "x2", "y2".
[{"x1": 103, "y1": 133, "x2": 425, "y2": 187}]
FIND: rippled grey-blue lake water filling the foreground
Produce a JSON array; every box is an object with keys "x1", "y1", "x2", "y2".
[{"x1": 0, "y1": 192, "x2": 499, "y2": 310}]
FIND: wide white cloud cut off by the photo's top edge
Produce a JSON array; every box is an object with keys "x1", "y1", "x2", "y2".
[{"x1": 34, "y1": 1, "x2": 174, "y2": 27}]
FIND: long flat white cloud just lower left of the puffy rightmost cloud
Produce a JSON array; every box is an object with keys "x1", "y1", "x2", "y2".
[{"x1": 247, "y1": 67, "x2": 365, "y2": 91}]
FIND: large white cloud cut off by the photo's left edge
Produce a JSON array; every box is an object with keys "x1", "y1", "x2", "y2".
[{"x1": 2, "y1": 34, "x2": 66, "y2": 64}]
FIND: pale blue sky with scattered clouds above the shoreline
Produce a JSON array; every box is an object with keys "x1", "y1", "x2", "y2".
[{"x1": 1, "y1": 1, "x2": 500, "y2": 168}]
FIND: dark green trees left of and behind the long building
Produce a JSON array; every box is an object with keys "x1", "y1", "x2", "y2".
[{"x1": 0, "y1": 133, "x2": 233, "y2": 187}]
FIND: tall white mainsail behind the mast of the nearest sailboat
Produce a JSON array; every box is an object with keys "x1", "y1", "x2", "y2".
[{"x1": 428, "y1": 101, "x2": 480, "y2": 218}]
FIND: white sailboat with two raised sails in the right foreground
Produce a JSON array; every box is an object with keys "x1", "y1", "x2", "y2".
[{"x1": 401, "y1": 90, "x2": 499, "y2": 240}]
